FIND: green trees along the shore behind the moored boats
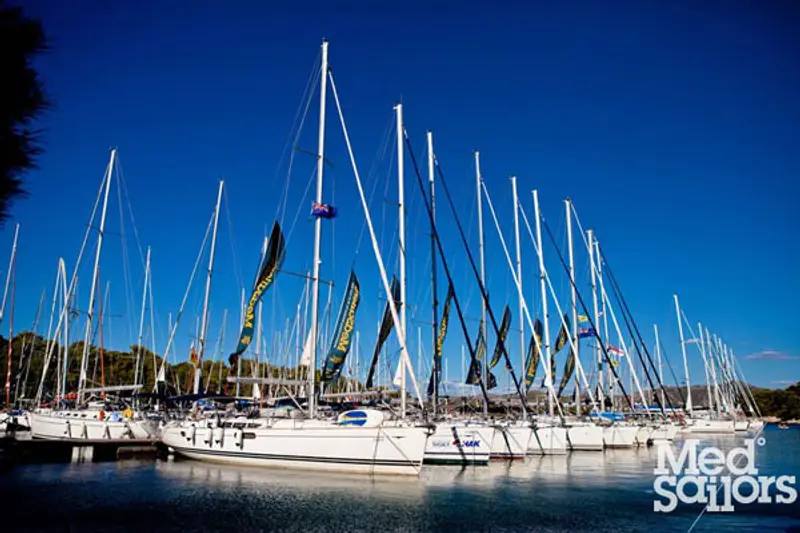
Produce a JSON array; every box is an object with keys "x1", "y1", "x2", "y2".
[{"x1": 0, "y1": 331, "x2": 800, "y2": 424}]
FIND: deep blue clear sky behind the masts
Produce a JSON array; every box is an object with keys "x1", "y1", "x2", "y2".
[{"x1": 0, "y1": 0, "x2": 800, "y2": 387}]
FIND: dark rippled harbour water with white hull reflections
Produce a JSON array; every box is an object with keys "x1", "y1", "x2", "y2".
[{"x1": 0, "y1": 428, "x2": 800, "y2": 533}]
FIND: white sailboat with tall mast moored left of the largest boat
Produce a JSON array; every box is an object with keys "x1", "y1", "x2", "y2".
[{"x1": 30, "y1": 149, "x2": 155, "y2": 442}]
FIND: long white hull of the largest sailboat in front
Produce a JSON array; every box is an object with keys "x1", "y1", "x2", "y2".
[{"x1": 161, "y1": 420, "x2": 430, "y2": 476}]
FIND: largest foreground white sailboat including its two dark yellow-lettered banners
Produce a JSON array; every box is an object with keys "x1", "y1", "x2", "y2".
[{"x1": 162, "y1": 41, "x2": 431, "y2": 475}]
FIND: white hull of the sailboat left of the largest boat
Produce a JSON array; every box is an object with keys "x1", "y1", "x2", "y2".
[{"x1": 29, "y1": 410, "x2": 153, "y2": 442}]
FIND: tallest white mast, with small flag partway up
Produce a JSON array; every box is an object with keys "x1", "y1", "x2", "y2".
[{"x1": 306, "y1": 40, "x2": 328, "y2": 416}]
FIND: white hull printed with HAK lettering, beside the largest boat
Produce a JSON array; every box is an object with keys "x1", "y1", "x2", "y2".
[{"x1": 424, "y1": 422, "x2": 495, "y2": 465}]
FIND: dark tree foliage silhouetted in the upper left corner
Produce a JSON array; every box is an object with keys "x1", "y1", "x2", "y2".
[{"x1": 0, "y1": 0, "x2": 50, "y2": 222}]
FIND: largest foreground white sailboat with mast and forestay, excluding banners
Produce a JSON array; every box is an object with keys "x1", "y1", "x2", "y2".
[{"x1": 162, "y1": 41, "x2": 431, "y2": 475}]
